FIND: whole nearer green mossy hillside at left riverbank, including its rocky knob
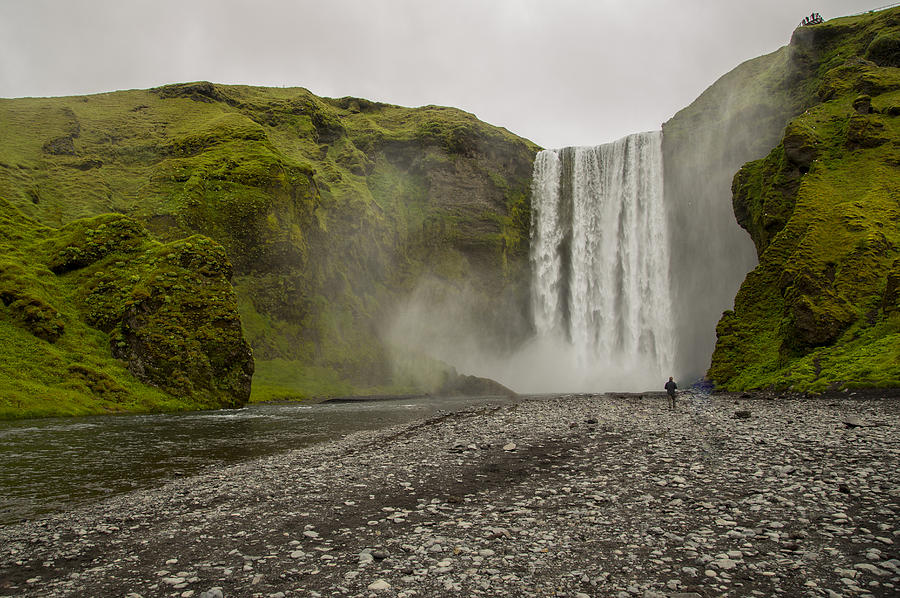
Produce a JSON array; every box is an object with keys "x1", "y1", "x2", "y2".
[{"x1": 0, "y1": 199, "x2": 253, "y2": 416}]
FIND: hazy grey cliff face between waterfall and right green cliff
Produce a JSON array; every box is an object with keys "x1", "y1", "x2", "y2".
[{"x1": 663, "y1": 36, "x2": 813, "y2": 379}]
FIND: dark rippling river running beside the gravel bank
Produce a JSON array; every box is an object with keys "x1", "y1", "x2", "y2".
[{"x1": 0, "y1": 397, "x2": 512, "y2": 524}]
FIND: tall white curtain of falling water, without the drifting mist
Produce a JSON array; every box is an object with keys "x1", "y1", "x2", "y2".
[{"x1": 531, "y1": 132, "x2": 675, "y2": 391}]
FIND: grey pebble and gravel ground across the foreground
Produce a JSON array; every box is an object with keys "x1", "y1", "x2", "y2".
[{"x1": 0, "y1": 393, "x2": 900, "y2": 598}]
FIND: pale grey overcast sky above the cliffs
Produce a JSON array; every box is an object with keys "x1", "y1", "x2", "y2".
[{"x1": 0, "y1": 0, "x2": 891, "y2": 148}]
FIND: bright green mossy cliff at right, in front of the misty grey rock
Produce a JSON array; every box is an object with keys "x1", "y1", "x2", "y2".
[{"x1": 708, "y1": 9, "x2": 900, "y2": 391}]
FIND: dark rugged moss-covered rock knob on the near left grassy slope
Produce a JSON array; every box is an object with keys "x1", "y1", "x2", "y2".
[{"x1": 50, "y1": 216, "x2": 253, "y2": 407}]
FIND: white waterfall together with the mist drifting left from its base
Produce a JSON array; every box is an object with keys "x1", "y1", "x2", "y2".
[{"x1": 391, "y1": 132, "x2": 676, "y2": 393}]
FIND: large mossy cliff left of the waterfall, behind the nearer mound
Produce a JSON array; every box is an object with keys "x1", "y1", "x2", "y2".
[{"x1": 0, "y1": 82, "x2": 537, "y2": 410}]
